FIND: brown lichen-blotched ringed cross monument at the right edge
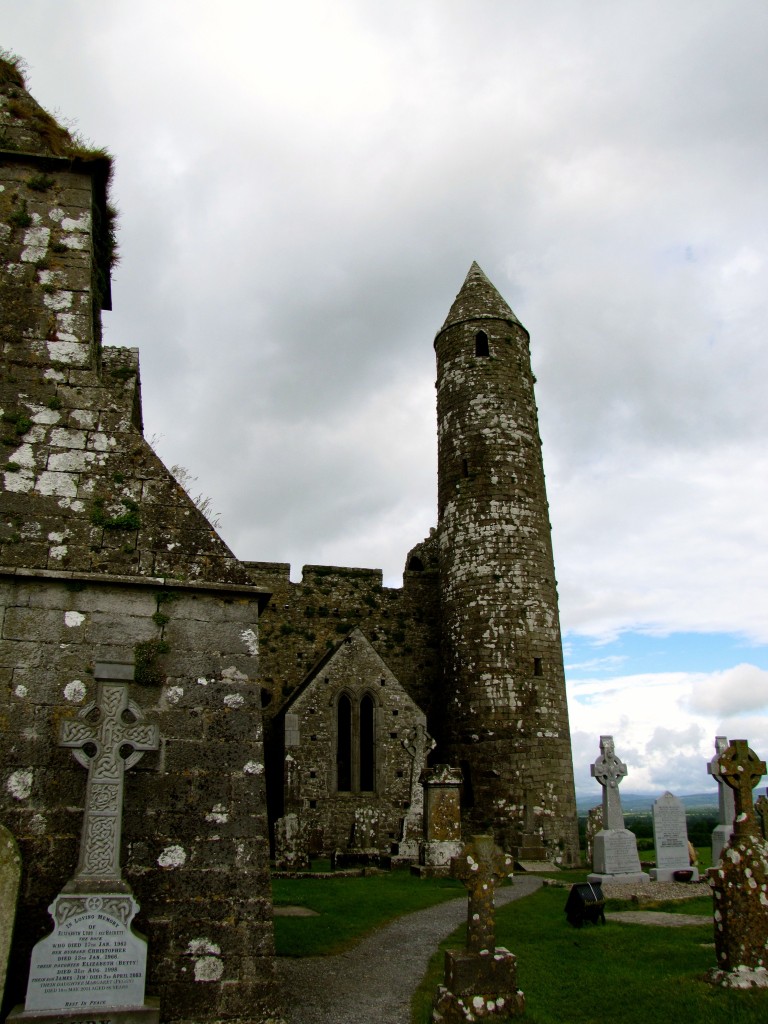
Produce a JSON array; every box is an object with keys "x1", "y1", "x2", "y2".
[{"x1": 710, "y1": 739, "x2": 768, "y2": 988}]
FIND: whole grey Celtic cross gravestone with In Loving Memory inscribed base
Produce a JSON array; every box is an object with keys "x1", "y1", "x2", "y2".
[{"x1": 8, "y1": 663, "x2": 160, "y2": 1024}]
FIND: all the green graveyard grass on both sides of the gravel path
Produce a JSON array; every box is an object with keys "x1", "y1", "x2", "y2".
[{"x1": 273, "y1": 848, "x2": 768, "y2": 1024}]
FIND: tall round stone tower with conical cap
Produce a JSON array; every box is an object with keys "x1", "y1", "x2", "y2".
[{"x1": 435, "y1": 263, "x2": 579, "y2": 865}]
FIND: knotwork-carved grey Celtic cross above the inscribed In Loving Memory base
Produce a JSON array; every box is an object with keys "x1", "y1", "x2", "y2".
[{"x1": 58, "y1": 665, "x2": 160, "y2": 892}]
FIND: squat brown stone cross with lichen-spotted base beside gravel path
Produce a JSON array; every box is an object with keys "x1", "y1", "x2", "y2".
[{"x1": 432, "y1": 836, "x2": 525, "y2": 1024}]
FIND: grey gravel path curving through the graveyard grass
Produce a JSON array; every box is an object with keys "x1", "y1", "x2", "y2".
[{"x1": 276, "y1": 874, "x2": 542, "y2": 1024}]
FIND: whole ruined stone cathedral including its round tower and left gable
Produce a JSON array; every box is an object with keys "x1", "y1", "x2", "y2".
[{"x1": 0, "y1": 61, "x2": 579, "y2": 1021}]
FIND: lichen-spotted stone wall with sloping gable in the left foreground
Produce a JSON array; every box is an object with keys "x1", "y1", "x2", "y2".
[{"x1": 0, "y1": 61, "x2": 276, "y2": 1021}]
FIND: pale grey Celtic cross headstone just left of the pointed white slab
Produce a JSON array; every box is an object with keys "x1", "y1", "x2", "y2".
[{"x1": 588, "y1": 736, "x2": 648, "y2": 882}]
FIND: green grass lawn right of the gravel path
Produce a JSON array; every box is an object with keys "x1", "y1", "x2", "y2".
[{"x1": 412, "y1": 888, "x2": 768, "y2": 1024}]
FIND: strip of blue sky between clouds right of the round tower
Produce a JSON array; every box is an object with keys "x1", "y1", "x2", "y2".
[{"x1": 563, "y1": 632, "x2": 768, "y2": 680}]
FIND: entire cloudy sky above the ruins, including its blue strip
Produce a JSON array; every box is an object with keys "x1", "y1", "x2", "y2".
[{"x1": 6, "y1": 0, "x2": 768, "y2": 797}]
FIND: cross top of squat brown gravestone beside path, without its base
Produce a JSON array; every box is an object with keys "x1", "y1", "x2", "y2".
[{"x1": 451, "y1": 836, "x2": 512, "y2": 953}]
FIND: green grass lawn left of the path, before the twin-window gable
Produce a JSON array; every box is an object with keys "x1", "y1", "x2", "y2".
[{"x1": 272, "y1": 871, "x2": 466, "y2": 956}]
